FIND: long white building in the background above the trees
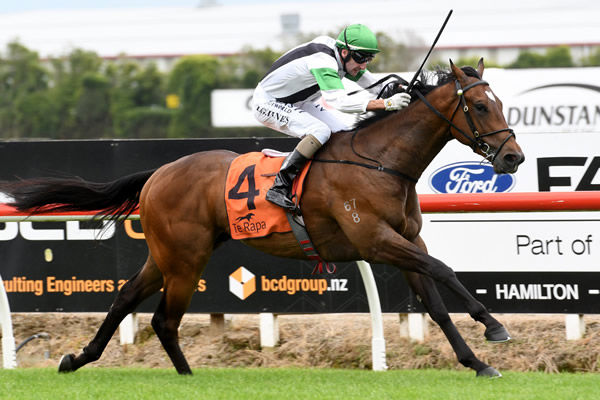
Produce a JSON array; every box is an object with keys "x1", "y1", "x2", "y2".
[{"x1": 0, "y1": 0, "x2": 600, "y2": 69}]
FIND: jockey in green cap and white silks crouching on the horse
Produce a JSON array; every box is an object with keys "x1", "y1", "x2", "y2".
[{"x1": 252, "y1": 24, "x2": 410, "y2": 211}]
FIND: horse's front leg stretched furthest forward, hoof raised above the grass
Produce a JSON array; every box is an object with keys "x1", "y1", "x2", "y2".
[{"x1": 359, "y1": 223, "x2": 510, "y2": 342}]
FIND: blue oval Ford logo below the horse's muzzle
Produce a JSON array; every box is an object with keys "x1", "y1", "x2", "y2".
[{"x1": 429, "y1": 161, "x2": 515, "y2": 193}]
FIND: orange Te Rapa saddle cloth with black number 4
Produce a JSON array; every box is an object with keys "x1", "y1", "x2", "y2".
[{"x1": 225, "y1": 151, "x2": 336, "y2": 274}]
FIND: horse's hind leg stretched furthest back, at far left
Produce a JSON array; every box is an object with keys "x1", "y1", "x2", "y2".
[{"x1": 58, "y1": 256, "x2": 163, "y2": 372}]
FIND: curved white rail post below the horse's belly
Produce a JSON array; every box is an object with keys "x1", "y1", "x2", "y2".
[{"x1": 356, "y1": 260, "x2": 387, "y2": 371}]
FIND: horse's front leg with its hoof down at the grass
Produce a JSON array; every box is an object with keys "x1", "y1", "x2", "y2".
[{"x1": 404, "y1": 272, "x2": 501, "y2": 377}]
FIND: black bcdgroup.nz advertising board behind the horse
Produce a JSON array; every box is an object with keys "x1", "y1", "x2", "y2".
[{"x1": 0, "y1": 139, "x2": 416, "y2": 313}]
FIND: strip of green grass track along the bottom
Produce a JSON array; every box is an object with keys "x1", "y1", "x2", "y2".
[{"x1": 0, "y1": 367, "x2": 600, "y2": 400}]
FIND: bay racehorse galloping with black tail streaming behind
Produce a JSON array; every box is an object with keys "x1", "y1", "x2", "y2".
[{"x1": 0, "y1": 60, "x2": 524, "y2": 376}]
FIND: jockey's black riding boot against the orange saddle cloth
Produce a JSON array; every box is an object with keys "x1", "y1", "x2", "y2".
[{"x1": 265, "y1": 150, "x2": 308, "y2": 211}]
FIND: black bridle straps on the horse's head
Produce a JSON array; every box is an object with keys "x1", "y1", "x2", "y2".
[{"x1": 414, "y1": 80, "x2": 515, "y2": 163}]
